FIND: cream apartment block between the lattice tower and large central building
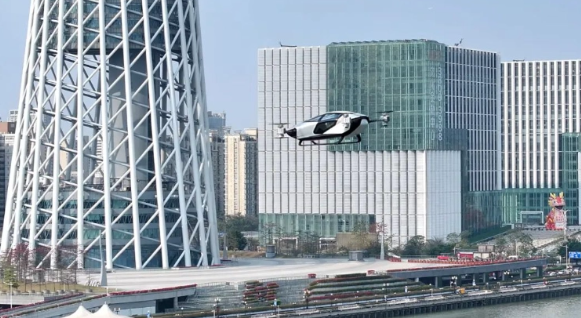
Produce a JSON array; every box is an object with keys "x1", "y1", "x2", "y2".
[{"x1": 224, "y1": 128, "x2": 258, "y2": 215}]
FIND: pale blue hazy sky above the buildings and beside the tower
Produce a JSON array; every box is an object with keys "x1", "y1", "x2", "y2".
[{"x1": 0, "y1": 0, "x2": 581, "y2": 129}]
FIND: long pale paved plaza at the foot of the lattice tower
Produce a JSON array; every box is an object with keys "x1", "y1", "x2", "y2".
[{"x1": 91, "y1": 257, "x2": 453, "y2": 291}]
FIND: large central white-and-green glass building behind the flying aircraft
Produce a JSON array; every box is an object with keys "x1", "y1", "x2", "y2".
[{"x1": 258, "y1": 40, "x2": 500, "y2": 244}]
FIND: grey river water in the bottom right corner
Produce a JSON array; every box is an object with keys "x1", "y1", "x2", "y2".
[{"x1": 417, "y1": 296, "x2": 581, "y2": 318}]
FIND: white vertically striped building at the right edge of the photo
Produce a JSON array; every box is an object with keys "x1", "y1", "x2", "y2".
[{"x1": 502, "y1": 60, "x2": 581, "y2": 224}]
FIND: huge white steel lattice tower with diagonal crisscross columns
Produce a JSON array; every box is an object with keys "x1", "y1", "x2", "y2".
[{"x1": 0, "y1": 0, "x2": 220, "y2": 269}]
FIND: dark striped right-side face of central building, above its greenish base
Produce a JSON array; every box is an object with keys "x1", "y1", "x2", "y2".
[{"x1": 446, "y1": 47, "x2": 501, "y2": 191}]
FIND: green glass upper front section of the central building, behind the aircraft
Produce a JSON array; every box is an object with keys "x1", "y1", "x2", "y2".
[{"x1": 327, "y1": 40, "x2": 448, "y2": 151}]
